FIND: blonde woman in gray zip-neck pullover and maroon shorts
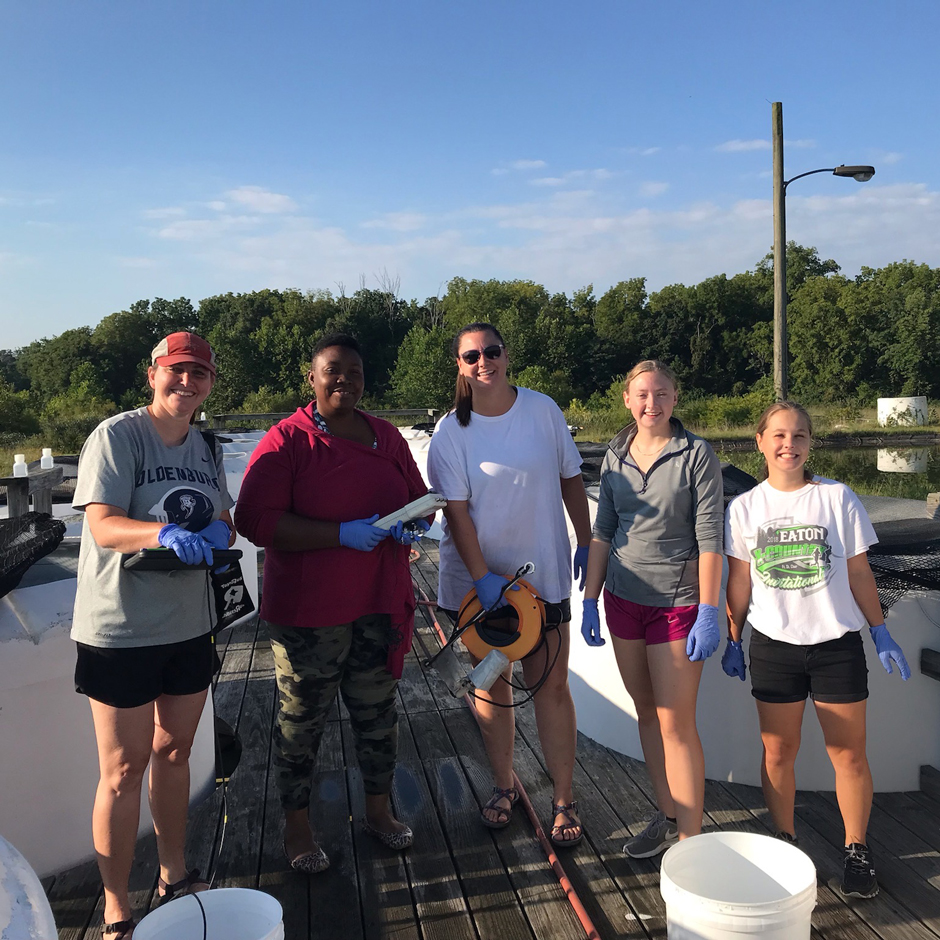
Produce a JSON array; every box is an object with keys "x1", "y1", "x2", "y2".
[{"x1": 581, "y1": 360, "x2": 723, "y2": 858}]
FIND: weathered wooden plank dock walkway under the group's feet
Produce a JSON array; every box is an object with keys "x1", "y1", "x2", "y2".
[{"x1": 44, "y1": 542, "x2": 940, "y2": 940}]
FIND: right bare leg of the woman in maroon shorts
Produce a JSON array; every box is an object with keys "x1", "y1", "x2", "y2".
[{"x1": 646, "y1": 640, "x2": 705, "y2": 839}]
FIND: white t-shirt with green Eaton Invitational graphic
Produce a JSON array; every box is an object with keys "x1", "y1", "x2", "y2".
[{"x1": 725, "y1": 477, "x2": 878, "y2": 646}]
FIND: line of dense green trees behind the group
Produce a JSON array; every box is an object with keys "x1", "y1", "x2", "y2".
[{"x1": 0, "y1": 242, "x2": 940, "y2": 440}]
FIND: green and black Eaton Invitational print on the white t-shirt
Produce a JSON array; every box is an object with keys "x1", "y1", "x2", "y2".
[{"x1": 751, "y1": 519, "x2": 832, "y2": 591}]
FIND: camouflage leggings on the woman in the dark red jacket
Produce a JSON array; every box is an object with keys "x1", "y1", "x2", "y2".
[{"x1": 267, "y1": 614, "x2": 398, "y2": 810}]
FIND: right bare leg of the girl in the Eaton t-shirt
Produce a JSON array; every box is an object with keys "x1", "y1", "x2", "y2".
[{"x1": 815, "y1": 701, "x2": 873, "y2": 845}]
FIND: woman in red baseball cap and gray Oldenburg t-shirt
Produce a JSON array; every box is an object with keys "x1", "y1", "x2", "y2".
[{"x1": 72, "y1": 332, "x2": 234, "y2": 940}]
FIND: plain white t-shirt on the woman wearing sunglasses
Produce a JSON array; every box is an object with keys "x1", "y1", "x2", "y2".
[{"x1": 428, "y1": 388, "x2": 581, "y2": 610}]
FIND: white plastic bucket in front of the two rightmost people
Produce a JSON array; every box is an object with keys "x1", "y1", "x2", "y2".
[{"x1": 660, "y1": 832, "x2": 816, "y2": 940}]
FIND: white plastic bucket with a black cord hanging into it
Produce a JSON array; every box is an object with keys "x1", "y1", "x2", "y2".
[{"x1": 134, "y1": 888, "x2": 284, "y2": 940}]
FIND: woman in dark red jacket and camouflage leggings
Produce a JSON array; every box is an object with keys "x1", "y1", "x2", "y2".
[{"x1": 235, "y1": 333, "x2": 427, "y2": 874}]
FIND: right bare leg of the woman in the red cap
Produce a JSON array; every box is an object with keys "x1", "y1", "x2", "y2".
[{"x1": 150, "y1": 690, "x2": 208, "y2": 884}]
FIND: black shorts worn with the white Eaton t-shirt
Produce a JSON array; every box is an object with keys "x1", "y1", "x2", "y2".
[{"x1": 748, "y1": 630, "x2": 868, "y2": 705}]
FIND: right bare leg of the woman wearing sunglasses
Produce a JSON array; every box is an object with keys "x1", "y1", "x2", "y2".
[{"x1": 522, "y1": 623, "x2": 580, "y2": 839}]
